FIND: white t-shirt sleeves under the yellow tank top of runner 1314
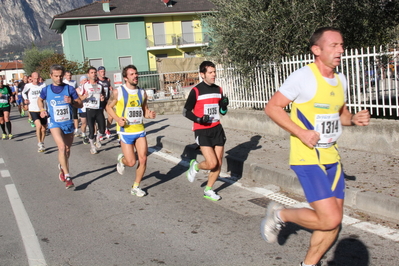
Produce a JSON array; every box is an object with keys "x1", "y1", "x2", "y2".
[{"x1": 279, "y1": 66, "x2": 347, "y2": 103}]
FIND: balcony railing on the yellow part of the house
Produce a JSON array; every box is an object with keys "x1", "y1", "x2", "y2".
[{"x1": 147, "y1": 32, "x2": 209, "y2": 47}]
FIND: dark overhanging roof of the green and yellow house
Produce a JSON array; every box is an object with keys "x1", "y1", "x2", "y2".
[{"x1": 50, "y1": 0, "x2": 215, "y2": 30}]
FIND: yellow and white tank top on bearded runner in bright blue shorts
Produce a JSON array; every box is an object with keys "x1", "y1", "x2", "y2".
[{"x1": 115, "y1": 86, "x2": 144, "y2": 134}]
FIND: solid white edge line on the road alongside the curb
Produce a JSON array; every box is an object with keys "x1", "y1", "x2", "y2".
[{"x1": 148, "y1": 148, "x2": 399, "y2": 241}]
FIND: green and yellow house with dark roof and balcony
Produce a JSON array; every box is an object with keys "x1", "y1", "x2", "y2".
[{"x1": 50, "y1": 0, "x2": 213, "y2": 71}]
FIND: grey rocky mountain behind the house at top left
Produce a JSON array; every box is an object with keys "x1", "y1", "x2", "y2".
[{"x1": 0, "y1": 0, "x2": 95, "y2": 59}]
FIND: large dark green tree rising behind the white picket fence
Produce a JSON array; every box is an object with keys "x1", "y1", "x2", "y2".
[{"x1": 203, "y1": 0, "x2": 399, "y2": 69}]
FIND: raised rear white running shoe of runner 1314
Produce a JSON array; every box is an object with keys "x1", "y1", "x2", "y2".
[{"x1": 260, "y1": 201, "x2": 285, "y2": 243}]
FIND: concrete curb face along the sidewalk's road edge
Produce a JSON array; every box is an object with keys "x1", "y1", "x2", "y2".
[{"x1": 147, "y1": 135, "x2": 399, "y2": 222}]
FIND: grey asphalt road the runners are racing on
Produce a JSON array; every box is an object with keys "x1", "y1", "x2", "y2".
[{"x1": 0, "y1": 108, "x2": 399, "y2": 266}]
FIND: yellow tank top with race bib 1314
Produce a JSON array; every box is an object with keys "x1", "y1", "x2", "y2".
[{"x1": 290, "y1": 63, "x2": 345, "y2": 165}]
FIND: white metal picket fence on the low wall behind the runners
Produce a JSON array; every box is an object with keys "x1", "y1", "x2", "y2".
[{"x1": 140, "y1": 47, "x2": 399, "y2": 118}]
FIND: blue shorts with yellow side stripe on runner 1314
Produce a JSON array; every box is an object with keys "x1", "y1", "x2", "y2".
[{"x1": 291, "y1": 162, "x2": 345, "y2": 203}]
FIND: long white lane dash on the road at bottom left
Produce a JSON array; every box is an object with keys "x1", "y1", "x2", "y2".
[{"x1": 6, "y1": 184, "x2": 47, "y2": 266}]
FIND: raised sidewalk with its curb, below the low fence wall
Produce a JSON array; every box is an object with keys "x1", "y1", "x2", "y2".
[{"x1": 145, "y1": 114, "x2": 399, "y2": 222}]
